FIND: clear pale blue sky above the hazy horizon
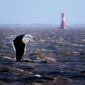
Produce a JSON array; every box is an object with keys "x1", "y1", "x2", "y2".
[{"x1": 0, "y1": 0, "x2": 85, "y2": 25}]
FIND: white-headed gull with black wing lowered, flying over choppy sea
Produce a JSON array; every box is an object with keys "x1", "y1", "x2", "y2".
[{"x1": 13, "y1": 34, "x2": 34, "y2": 62}]
